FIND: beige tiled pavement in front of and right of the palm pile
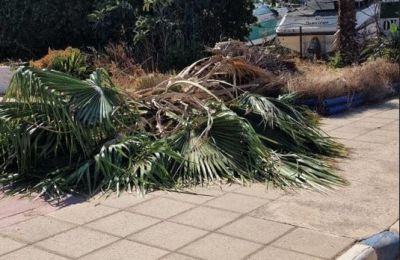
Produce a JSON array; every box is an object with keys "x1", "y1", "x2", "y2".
[{"x1": 0, "y1": 100, "x2": 399, "y2": 260}]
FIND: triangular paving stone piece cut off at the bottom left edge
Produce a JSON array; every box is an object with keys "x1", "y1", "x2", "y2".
[{"x1": 0, "y1": 246, "x2": 68, "y2": 260}]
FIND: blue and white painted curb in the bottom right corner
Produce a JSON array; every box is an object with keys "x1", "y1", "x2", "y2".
[{"x1": 337, "y1": 221, "x2": 400, "y2": 260}]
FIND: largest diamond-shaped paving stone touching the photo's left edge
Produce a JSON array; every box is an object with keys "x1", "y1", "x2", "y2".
[{"x1": 0, "y1": 216, "x2": 74, "y2": 243}]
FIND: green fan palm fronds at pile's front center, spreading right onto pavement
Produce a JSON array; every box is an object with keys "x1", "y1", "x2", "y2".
[{"x1": 167, "y1": 108, "x2": 345, "y2": 191}]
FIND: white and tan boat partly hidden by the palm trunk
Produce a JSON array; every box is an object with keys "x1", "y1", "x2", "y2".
[{"x1": 276, "y1": 0, "x2": 379, "y2": 56}]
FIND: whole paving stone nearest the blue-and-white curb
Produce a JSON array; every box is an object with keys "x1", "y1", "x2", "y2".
[{"x1": 272, "y1": 228, "x2": 354, "y2": 259}]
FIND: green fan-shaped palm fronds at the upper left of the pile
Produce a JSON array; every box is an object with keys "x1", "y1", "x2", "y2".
[{"x1": 6, "y1": 67, "x2": 120, "y2": 124}]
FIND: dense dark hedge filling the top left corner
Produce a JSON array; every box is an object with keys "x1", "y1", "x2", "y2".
[{"x1": 0, "y1": 0, "x2": 93, "y2": 59}]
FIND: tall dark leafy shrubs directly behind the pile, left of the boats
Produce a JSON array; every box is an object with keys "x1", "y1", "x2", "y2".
[{"x1": 91, "y1": 0, "x2": 255, "y2": 71}]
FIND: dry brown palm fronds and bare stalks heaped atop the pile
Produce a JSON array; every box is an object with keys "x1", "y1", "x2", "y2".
[{"x1": 133, "y1": 55, "x2": 283, "y2": 136}]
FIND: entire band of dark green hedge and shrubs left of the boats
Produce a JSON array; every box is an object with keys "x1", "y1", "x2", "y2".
[{"x1": 0, "y1": 0, "x2": 256, "y2": 71}]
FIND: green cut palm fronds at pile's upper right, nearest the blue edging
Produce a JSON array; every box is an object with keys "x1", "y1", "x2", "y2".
[{"x1": 230, "y1": 93, "x2": 346, "y2": 156}]
